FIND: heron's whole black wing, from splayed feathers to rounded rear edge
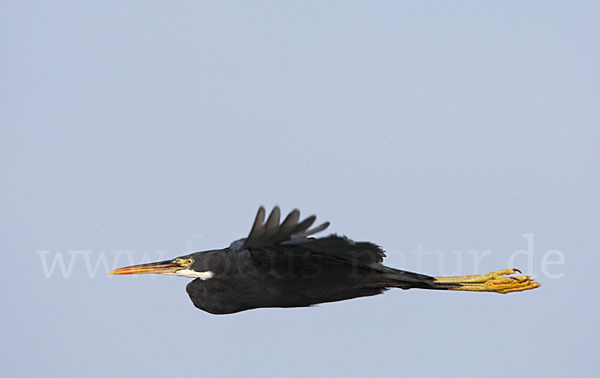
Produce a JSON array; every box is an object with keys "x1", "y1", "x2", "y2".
[{"x1": 240, "y1": 206, "x2": 385, "y2": 266}]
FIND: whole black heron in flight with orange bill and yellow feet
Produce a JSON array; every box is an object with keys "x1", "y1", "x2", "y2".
[{"x1": 110, "y1": 206, "x2": 540, "y2": 314}]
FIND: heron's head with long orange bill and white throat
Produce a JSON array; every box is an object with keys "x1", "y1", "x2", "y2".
[{"x1": 110, "y1": 253, "x2": 214, "y2": 280}]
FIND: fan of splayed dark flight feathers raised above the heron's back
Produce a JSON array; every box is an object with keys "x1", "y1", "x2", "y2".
[{"x1": 242, "y1": 206, "x2": 329, "y2": 248}]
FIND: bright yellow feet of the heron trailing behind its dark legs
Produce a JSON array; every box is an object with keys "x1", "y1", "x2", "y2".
[{"x1": 435, "y1": 269, "x2": 540, "y2": 294}]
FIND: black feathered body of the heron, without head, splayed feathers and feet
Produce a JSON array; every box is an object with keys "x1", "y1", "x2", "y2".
[{"x1": 187, "y1": 236, "x2": 433, "y2": 314}]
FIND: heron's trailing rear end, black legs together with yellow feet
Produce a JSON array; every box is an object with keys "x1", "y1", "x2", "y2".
[{"x1": 386, "y1": 269, "x2": 540, "y2": 294}]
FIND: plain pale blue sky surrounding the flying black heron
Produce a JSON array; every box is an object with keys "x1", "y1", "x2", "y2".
[{"x1": 0, "y1": 1, "x2": 600, "y2": 378}]
